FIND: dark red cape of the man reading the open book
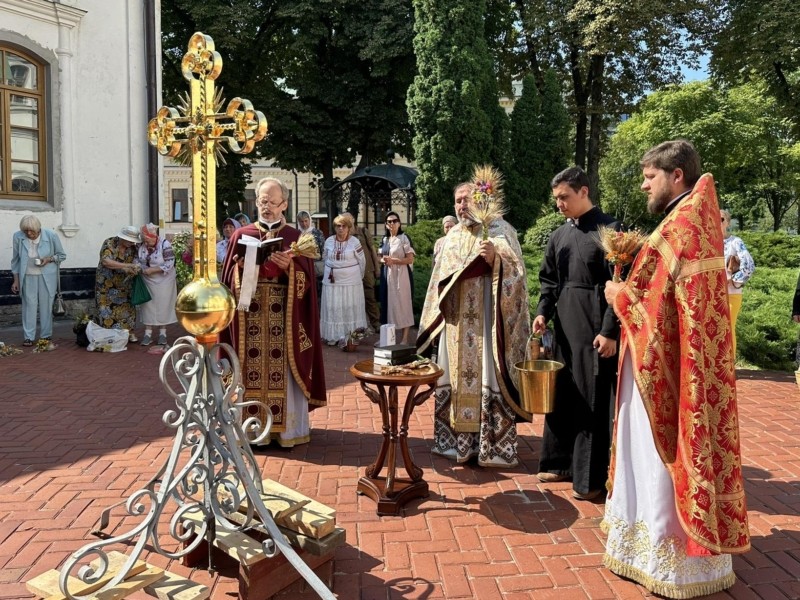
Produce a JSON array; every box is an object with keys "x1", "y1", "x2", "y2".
[{"x1": 220, "y1": 224, "x2": 326, "y2": 410}]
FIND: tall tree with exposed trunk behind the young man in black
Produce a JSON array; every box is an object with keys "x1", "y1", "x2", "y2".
[{"x1": 490, "y1": 0, "x2": 718, "y2": 201}]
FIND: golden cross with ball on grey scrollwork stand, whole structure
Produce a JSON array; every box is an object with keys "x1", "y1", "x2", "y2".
[{"x1": 59, "y1": 33, "x2": 335, "y2": 600}]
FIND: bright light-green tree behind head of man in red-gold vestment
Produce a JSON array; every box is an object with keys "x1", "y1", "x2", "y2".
[{"x1": 600, "y1": 82, "x2": 800, "y2": 230}]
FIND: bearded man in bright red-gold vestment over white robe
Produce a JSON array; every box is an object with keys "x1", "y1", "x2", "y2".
[{"x1": 602, "y1": 140, "x2": 750, "y2": 598}]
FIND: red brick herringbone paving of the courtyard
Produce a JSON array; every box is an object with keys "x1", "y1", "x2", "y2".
[{"x1": 0, "y1": 324, "x2": 800, "y2": 600}]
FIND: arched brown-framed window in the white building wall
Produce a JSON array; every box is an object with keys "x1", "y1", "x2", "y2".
[{"x1": 0, "y1": 44, "x2": 47, "y2": 201}]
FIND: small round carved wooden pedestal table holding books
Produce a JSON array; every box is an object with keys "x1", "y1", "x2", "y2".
[{"x1": 350, "y1": 359, "x2": 442, "y2": 515}]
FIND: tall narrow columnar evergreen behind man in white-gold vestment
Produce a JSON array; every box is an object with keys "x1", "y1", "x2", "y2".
[{"x1": 407, "y1": 0, "x2": 508, "y2": 217}]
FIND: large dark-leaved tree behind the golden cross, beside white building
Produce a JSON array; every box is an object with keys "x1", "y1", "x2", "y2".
[{"x1": 161, "y1": 0, "x2": 415, "y2": 221}]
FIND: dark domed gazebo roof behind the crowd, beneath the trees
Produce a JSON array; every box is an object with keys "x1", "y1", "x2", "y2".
[{"x1": 328, "y1": 155, "x2": 418, "y2": 235}]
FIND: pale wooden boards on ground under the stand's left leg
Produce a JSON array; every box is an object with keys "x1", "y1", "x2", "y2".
[{"x1": 25, "y1": 551, "x2": 210, "y2": 600}]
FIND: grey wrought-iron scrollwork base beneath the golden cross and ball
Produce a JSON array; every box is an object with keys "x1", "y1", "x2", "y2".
[{"x1": 59, "y1": 336, "x2": 335, "y2": 600}]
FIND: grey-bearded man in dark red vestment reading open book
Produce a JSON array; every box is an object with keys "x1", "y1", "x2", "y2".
[{"x1": 220, "y1": 177, "x2": 326, "y2": 447}]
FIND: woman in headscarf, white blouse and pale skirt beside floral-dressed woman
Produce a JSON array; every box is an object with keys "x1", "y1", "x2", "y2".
[{"x1": 136, "y1": 223, "x2": 178, "y2": 346}]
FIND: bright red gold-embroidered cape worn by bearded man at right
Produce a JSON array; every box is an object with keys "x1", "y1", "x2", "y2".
[{"x1": 609, "y1": 174, "x2": 750, "y2": 556}]
